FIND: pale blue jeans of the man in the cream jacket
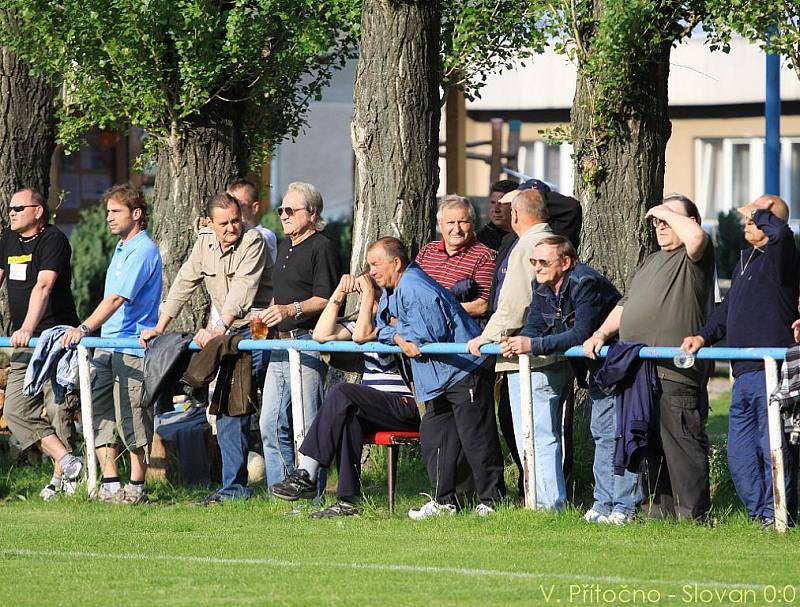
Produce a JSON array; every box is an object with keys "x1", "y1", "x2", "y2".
[{"x1": 508, "y1": 363, "x2": 572, "y2": 510}]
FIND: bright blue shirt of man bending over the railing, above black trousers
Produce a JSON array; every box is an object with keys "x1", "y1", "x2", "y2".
[{"x1": 377, "y1": 263, "x2": 486, "y2": 401}]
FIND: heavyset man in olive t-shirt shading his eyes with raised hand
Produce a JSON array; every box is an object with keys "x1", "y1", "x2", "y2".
[{"x1": 583, "y1": 194, "x2": 714, "y2": 519}]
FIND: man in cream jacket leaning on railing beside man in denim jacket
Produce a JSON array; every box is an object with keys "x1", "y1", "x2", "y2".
[{"x1": 467, "y1": 188, "x2": 555, "y2": 507}]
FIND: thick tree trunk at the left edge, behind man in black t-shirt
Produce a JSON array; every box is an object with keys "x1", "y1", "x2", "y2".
[{"x1": 0, "y1": 47, "x2": 55, "y2": 335}]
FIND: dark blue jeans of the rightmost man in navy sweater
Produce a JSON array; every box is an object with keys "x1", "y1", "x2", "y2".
[{"x1": 728, "y1": 370, "x2": 793, "y2": 518}]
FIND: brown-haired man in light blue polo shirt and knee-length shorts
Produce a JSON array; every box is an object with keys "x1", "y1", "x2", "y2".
[{"x1": 61, "y1": 185, "x2": 161, "y2": 504}]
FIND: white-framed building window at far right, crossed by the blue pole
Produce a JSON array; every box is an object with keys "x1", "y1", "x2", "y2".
[{"x1": 695, "y1": 137, "x2": 800, "y2": 223}]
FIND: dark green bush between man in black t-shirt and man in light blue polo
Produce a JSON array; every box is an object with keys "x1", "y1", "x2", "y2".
[{"x1": 69, "y1": 205, "x2": 119, "y2": 320}]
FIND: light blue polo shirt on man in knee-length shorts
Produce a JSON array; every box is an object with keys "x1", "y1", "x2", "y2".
[{"x1": 100, "y1": 230, "x2": 161, "y2": 356}]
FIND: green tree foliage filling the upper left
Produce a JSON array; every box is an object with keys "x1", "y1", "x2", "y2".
[{"x1": 0, "y1": 0, "x2": 359, "y2": 164}]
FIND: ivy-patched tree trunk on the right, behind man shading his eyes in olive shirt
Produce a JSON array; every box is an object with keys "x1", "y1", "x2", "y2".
[{"x1": 572, "y1": 38, "x2": 672, "y2": 292}]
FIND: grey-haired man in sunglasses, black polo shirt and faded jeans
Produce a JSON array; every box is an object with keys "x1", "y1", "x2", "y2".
[{"x1": 259, "y1": 182, "x2": 341, "y2": 489}]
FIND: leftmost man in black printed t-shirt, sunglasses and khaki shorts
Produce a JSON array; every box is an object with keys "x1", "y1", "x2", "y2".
[{"x1": 0, "y1": 188, "x2": 83, "y2": 500}]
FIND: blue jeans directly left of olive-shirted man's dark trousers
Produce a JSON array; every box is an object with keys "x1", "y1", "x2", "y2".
[{"x1": 589, "y1": 382, "x2": 642, "y2": 516}]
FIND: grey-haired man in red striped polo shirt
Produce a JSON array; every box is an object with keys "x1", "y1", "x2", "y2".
[{"x1": 416, "y1": 194, "x2": 495, "y2": 322}]
